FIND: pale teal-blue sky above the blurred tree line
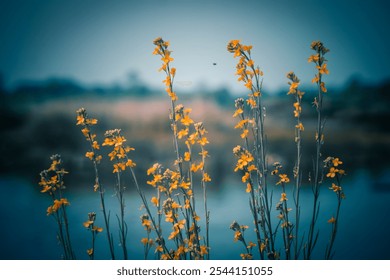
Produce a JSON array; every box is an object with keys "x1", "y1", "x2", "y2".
[{"x1": 0, "y1": 0, "x2": 390, "y2": 91}]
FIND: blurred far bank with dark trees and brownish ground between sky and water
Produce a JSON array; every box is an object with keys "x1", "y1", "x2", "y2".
[{"x1": 0, "y1": 74, "x2": 390, "y2": 189}]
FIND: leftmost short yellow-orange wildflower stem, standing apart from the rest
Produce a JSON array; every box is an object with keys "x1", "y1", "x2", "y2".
[{"x1": 39, "y1": 154, "x2": 75, "y2": 259}]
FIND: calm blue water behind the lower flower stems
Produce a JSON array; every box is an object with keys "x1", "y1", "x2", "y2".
[{"x1": 0, "y1": 172, "x2": 390, "y2": 259}]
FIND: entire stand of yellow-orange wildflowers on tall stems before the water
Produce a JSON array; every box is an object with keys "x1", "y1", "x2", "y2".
[{"x1": 39, "y1": 37, "x2": 345, "y2": 260}]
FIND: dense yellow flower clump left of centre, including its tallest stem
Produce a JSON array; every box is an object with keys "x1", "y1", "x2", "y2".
[{"x1": 141, "y1": 37, "x2": 211, "y2": 259}]
